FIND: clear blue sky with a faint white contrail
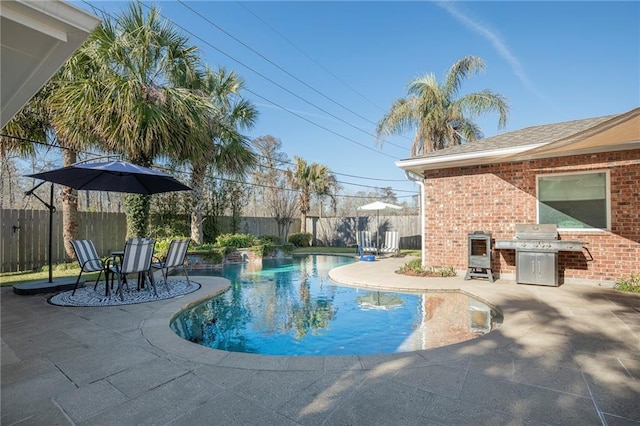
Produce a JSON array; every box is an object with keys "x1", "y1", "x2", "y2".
[{"x1": 74, "y1": 1, "x2": 640, "y2": 201}]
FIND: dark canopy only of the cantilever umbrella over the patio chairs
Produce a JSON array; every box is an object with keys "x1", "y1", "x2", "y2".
[{"x1": 27, "y1": 161, "x2": 191, "y2": 195}]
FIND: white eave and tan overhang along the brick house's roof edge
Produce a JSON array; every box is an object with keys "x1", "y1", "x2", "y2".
[{"x1": 395, "y1": 108, "x2": 640, "y2": 176}]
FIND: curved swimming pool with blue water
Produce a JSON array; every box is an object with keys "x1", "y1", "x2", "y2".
[{"x1": 171, "y1": 255, "x2": 500, "y2": 355}]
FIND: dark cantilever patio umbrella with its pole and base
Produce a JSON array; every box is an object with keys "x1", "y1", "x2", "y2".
[{"x1": 13, "y1": 161, "x2": 191, "y2": 294}]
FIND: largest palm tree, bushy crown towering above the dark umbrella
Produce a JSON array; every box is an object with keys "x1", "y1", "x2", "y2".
[{"x1": 52, "y1": 3, "x2": 212, "y2": 236}]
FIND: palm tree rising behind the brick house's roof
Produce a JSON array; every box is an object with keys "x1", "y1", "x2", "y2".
[{"x1": 376, "y1": 56, "x2": 509, "y2": 157}]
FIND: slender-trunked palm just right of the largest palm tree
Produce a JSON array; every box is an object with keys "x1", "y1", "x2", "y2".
[{"x1": 190, "y1": 68, "x2": 258, "y2": 244}]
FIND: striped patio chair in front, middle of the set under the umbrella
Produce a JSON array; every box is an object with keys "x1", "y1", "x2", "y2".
[{"x1": 106, "y1": 238, "x2": 158, "y2": 300}]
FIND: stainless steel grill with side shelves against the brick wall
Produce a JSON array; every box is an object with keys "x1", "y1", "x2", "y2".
[{"x1": 495, "y1": 224, "x2": 582, "y2": 286}]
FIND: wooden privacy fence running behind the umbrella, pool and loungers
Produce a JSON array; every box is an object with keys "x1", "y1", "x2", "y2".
[{"x1": 0, "y1": 209, "x2": 420, "y2": 273}]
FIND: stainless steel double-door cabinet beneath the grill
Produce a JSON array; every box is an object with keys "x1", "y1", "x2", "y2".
[{"x1": 516, "y1": 251, "x2": 558, "y2": 286}]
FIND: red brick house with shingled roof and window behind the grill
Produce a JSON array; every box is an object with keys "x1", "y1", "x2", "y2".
[{"x1": 396, "y1": 108, "x2": 640, "y2": 284}]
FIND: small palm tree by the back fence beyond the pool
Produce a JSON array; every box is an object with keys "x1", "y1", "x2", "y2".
[{"x1": 287, "y1": 156, "x2": 337, "y2": 232}]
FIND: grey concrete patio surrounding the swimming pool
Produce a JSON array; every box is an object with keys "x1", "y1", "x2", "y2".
[{"x1": 0, "y1": 258, "x2": 640, "y2": 425}]
